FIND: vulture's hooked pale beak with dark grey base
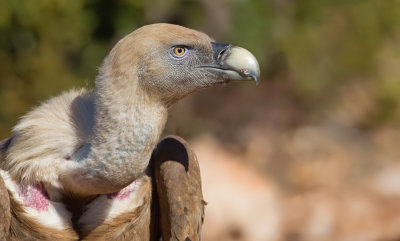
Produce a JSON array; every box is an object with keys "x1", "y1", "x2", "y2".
[{"x1": 209, "y1": 42, "x2": 260, "y2": 84}]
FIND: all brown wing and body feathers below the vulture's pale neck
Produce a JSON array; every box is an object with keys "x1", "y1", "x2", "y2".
[{"x1": 0, "y1": 136, "x2": 205, "y2": 241}]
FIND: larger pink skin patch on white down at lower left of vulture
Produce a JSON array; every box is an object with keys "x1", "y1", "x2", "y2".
[{"x1": 18, "y1": 185, "x2": 49, "y2": 211}]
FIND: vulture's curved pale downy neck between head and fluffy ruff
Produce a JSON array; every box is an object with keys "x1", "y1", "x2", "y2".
[{"x1": 64, "y1": 67, "x2": 167, "y2": 195}]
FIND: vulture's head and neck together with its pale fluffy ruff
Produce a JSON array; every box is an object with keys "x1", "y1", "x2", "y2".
[{"x1": 1, "y1": 24, "x2": 259, "y2": 199}]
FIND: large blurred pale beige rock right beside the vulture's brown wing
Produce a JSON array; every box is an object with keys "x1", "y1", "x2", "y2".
[{"x1": 192, "y1": 136, "x2": 281, "y2": 241}]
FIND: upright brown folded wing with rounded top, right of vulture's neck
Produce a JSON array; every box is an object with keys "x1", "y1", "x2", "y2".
[{"x1": 153, "y1": 136, "x2": 205, "y2": 241}]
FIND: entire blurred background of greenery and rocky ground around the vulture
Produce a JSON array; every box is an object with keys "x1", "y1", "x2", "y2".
[{"x1": 0, "y1": 0, "x2": 400, "y2": 241}]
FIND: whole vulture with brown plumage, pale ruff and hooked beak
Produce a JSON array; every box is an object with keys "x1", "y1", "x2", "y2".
[{"x1": 0, "y1": 23, "x2": 259, "y2": 241}]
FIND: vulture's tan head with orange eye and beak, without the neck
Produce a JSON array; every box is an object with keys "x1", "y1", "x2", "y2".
[{"x1": 96, "y1": 24, "x2": 259, "y2": 106}]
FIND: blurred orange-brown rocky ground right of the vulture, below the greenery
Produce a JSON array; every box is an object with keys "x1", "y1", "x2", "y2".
[{"x1": 192, "y1": 125, "x2": 400, "y2": 241}]
